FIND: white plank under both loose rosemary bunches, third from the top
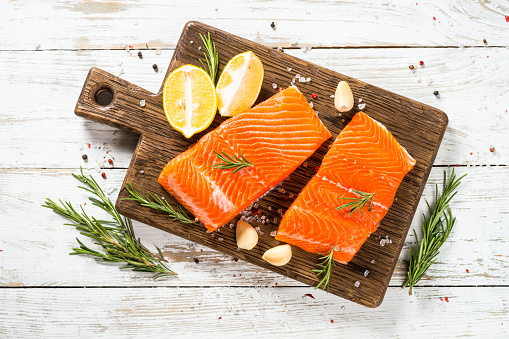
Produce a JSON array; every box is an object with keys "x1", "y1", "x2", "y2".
[{"x1": 0, "y1": 167, "x2": 509, "y2": 286}]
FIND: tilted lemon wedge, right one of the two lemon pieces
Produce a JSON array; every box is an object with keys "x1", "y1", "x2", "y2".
[{"x1": 216, "y1": 51, "x2": 263, "y2": 117}]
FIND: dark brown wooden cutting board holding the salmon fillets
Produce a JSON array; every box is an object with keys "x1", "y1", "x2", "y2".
[{"x1": 75, "y1": 22, "x2": 448, "y2": 307}]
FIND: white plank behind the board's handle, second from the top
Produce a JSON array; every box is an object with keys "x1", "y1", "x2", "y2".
[{"x1": 0, "y1": 48, "x2": 509, "y2": 168}]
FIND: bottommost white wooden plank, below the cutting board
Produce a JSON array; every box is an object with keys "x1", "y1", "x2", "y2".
[{"x1": 0, "y1": 287, "x2": 509, "y2": 338}]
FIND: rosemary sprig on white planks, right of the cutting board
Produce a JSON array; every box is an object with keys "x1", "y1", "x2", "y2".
[{"x1": 403, "y1": 168, "x2": 466, "y2": 295}]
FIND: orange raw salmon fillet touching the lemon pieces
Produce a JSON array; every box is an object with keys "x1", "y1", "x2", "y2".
[{"x1": 158, "y1": 86, "x2": 331, "y2": 232}]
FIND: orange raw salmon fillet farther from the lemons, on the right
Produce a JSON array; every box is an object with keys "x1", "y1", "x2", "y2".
[{"x1": 276, "y1": 112, "x2": 415, "y2": 263}]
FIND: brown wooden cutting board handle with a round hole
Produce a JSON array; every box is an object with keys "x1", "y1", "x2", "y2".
[{"x1": 74, "y1": 67, "x2": 169, "y2": 134}]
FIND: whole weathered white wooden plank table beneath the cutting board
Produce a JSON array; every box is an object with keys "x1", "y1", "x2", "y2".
[{"x1": 0, "y1": 0, "x2": 509, "y2": 338}]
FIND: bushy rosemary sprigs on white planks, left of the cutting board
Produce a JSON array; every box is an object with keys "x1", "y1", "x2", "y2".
[{"x1": 42, "y1": 169, "x2": 177, "y2": 279}]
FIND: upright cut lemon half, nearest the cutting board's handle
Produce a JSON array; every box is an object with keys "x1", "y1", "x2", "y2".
[{"x1": 163, "y1": 65, "x2": 217, "y2": 138}]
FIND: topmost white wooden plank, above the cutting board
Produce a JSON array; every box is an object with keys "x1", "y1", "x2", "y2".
[{"x1": 0, "y1": 0, "x2": 509, "y2": 50}]
